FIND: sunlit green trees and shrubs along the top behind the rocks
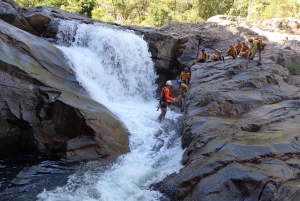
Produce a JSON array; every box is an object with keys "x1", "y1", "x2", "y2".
[{"x1": 15, "y1": 0, "x2": 300, "y2": 26}]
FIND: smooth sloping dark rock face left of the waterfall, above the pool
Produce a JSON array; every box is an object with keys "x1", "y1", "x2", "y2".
[{"x1": 0, "y1": 15, "x2": 129, "y2": 160}]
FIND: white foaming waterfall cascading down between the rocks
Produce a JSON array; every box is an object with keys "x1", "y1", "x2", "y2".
[{"x1": 37, "y1": 22, "x2": 183, "y2": 201}]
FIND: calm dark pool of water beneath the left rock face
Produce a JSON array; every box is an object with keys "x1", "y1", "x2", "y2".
[{"x1": 0, "y1": 153, "x2": 83, "y2": 201}]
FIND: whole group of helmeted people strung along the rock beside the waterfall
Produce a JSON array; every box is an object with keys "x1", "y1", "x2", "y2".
[{"x1": 158, "y1": 37, "x2": 266, "y2": 122}]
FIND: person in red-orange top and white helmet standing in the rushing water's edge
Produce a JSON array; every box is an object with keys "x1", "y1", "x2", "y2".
[{"x1": 158, "y1": 80, "x2": 175, "y2": 122}]
